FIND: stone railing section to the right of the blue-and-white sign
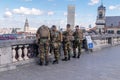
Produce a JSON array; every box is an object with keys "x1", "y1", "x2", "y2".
[{"x1": 92, "y1": 34, "x2": 120, "y2": 50}]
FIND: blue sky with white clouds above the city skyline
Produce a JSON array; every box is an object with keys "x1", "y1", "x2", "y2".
[{"x1": 0, "y1": 0, "x2": 120, "y2": 28}]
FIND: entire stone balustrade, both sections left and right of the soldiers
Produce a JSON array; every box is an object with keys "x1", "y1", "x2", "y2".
[{"x1": 0, "y1": 34, "x2": 120, "y2": 71}]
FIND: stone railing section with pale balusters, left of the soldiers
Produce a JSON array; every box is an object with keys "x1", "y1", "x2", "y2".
[{"x1": 0, "y1": 39, "x2": 38, "y2": 71}]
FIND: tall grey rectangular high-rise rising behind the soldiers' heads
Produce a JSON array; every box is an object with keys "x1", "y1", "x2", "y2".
[{"x1": 67, "y1": 5, "x2": 75, "y2": 29}]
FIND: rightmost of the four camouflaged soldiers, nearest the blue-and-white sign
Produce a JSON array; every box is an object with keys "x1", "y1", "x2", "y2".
[{"x1": 73, "y1": 25, "x2": 83, "y2": 58}]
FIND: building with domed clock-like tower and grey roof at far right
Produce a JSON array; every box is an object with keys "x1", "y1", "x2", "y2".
[{"x1": 96, "y1": 4, "x2": 120, "y2": 34}]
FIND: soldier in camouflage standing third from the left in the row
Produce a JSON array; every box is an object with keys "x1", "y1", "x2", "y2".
[{"x1": 62, "y1": 24, "x2": 73, "y2": 61}]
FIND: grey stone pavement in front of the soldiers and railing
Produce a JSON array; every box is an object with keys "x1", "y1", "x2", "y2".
[{"x1": 0, "y1": 46, "x2": 120, "y2": 80}]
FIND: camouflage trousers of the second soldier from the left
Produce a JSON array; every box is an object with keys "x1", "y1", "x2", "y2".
[{"x1": 52, "y1": 42, "x2": 59, "y2": 60}]
